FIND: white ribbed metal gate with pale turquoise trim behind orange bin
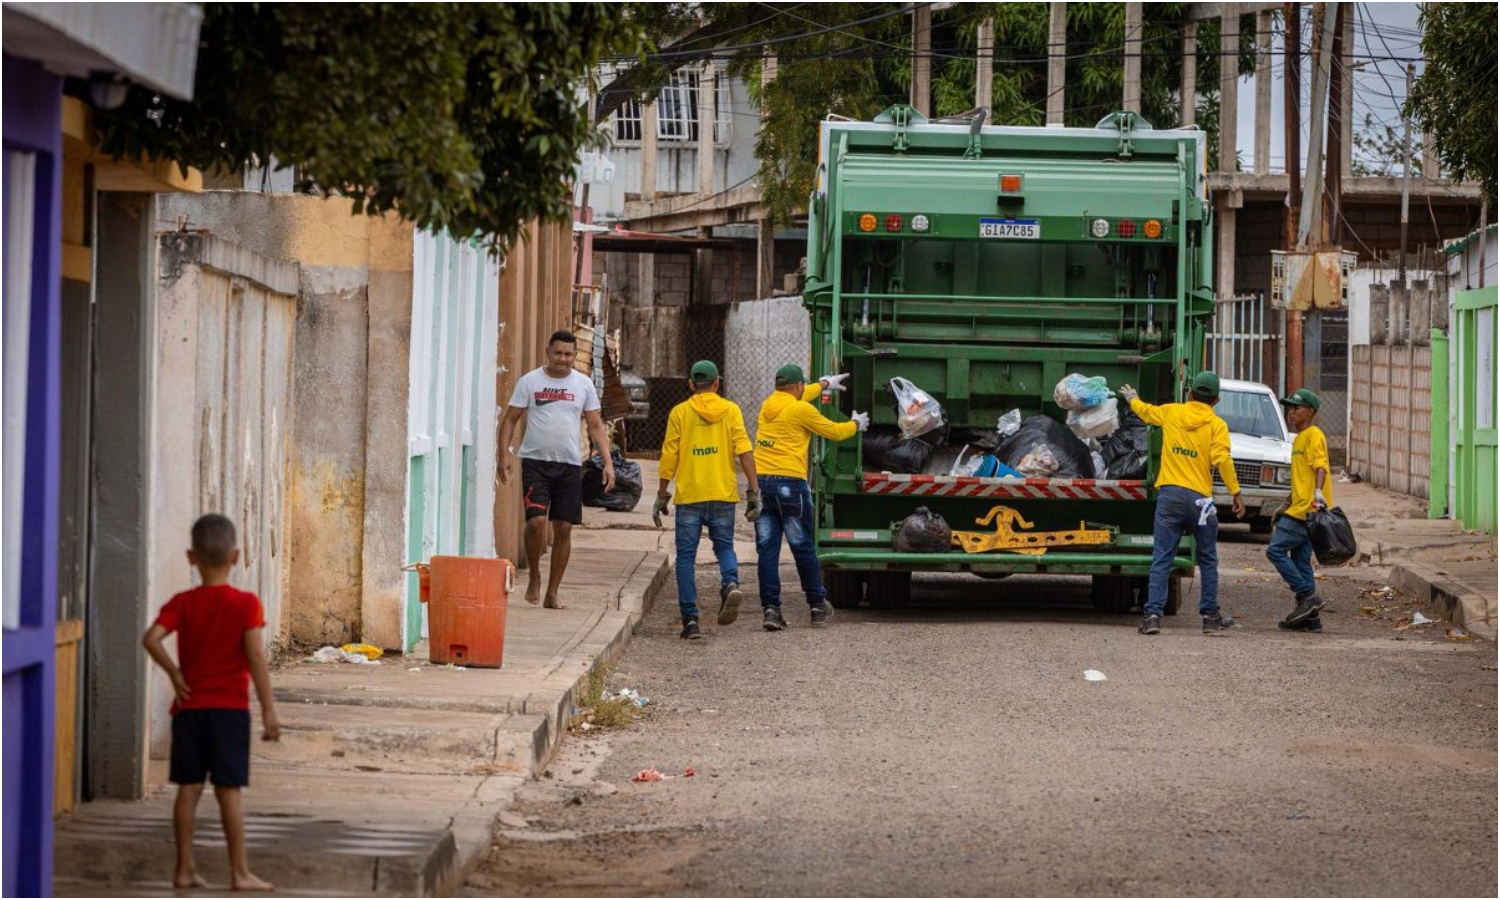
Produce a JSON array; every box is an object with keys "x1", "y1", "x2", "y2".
[{"x1": 402, "y1": 231, "x2": 500, "y2": 651}]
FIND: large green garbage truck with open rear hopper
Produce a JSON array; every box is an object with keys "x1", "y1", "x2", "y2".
[{"x1": 804, "y1": 105, "x2": 1214, "y2": 614}]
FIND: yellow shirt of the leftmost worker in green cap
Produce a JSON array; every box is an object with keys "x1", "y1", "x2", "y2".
[{"x1": 657, "y1": 393, "x2": 755, "y2": 506}]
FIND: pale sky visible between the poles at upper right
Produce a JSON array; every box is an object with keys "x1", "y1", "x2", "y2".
[{"x1": 1238, "y1": 2, "x2": 1422, "y2": 173}]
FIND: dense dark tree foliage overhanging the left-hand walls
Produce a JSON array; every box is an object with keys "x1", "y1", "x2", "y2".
[{"x1": 87, "y1": 3, "x2": 639, "y2": 243}]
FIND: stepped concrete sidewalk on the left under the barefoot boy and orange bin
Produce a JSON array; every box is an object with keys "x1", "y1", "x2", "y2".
[{"x1": 54, "y1": 510, "x2": 675, "y2": 897}]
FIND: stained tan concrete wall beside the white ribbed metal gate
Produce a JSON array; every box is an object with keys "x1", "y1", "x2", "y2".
[{"x1": 159, "y1": 191, "x2": 411, "y2": 647}]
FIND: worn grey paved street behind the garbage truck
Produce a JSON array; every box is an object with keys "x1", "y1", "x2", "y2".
[{"x1": 468, "y1": 530, "x2": 1497, "y2": 896}]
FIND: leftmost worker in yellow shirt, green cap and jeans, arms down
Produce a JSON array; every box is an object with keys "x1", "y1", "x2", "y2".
[{"x1": 651, "y1": 360, "x2": 761, "y2": 641}]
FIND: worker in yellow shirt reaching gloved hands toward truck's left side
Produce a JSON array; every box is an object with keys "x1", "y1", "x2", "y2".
[{"x1": 746, "y1": 363, "x2": 870, "y2": 632}]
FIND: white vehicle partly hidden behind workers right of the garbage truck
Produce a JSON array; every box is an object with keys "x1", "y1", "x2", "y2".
[{"x1": 1214, "y1": 378, "x2": 1292, "y2": 534}]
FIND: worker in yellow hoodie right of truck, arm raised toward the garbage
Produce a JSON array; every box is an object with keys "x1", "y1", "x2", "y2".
[{"x1": 1119, "y1": 372, "x2": 1245, "y2": 635}]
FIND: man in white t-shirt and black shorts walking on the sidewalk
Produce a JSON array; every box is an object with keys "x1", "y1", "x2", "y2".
[{"x1": 500, "y1": 332, "x2": 615, "y2": 609}]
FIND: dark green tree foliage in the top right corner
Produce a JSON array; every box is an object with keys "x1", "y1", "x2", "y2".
[{"x1": 1406, "y1": 3, "x2": 1497, "y2": 201}]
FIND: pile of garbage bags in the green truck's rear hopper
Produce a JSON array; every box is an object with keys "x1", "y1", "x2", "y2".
[{"x1": 864, "y1": 374, "x2": 1148, "y2": 480}]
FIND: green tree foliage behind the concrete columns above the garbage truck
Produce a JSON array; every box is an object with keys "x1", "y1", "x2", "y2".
[{"x1": 615, "y1": 3, "x2": 1254, "y2": 222}]
